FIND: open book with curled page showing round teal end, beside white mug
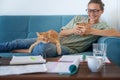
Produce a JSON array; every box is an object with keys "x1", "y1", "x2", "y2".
[{"x1": 46, "y1": 56, "x2": 80, "y2": 75}]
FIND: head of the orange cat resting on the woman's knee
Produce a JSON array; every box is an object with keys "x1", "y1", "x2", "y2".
[{"x1": 36, "y1": 32, "x2": 49, "y2": 43}]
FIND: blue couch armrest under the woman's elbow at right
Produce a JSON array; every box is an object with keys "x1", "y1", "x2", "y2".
[{"x1": 98, "y1": 37, "x2": 120, "y2": 66}]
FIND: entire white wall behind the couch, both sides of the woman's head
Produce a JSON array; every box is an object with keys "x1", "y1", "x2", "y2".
[{"x1": 0, "y1": 0, "x2": 120, "y2": 31}]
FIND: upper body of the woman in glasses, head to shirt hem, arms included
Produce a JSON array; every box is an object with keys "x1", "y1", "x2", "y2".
[{"x1": 60, "y1": 0, "x2": 120, "y2": 53}]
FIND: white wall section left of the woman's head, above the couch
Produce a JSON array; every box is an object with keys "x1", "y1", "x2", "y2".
[{"x1": 0, "y1": 0, "x2": 88, "y2": 15}]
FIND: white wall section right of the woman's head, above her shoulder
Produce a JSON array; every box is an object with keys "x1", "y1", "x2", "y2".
[{"x1": 102, "y1": 0, "x2": 120, "y2": 31}]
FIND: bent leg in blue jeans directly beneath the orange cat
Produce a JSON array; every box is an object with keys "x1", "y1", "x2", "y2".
[{"x1": 31, "y1": 42, "x2": 70, "y2": 58}]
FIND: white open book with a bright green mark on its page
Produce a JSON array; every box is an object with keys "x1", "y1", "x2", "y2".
[{"x1": 10, "y1": 55, "x2": 46, "y2": 64}]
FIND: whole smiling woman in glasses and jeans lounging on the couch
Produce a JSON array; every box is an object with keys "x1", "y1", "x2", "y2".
[{"x1": 0, "y1": 0, "x2": 120, "y2": 57}]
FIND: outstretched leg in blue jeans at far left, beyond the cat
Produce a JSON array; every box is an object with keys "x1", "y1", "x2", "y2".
[{"x1": 0, "y1": 38, "x2": 36, "y2": 52}]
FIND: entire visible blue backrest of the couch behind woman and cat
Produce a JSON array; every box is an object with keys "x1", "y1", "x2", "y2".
[{"x1": 0, "y1": 15, "x2": 86, "y2": 42}]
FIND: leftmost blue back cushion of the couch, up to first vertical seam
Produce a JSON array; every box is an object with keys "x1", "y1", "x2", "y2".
[{"x1": 0, "y1": 16, "x2": 28, "y2": 42}]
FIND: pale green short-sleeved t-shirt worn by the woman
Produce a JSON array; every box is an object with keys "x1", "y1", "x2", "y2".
[{"x1": 60, "y1": 16, "x2": 111, "y2": 53}]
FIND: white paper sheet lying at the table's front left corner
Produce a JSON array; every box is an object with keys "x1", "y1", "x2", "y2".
[{"x1": 0, "y1": 64, "x2": 47, "y2": 76}]
